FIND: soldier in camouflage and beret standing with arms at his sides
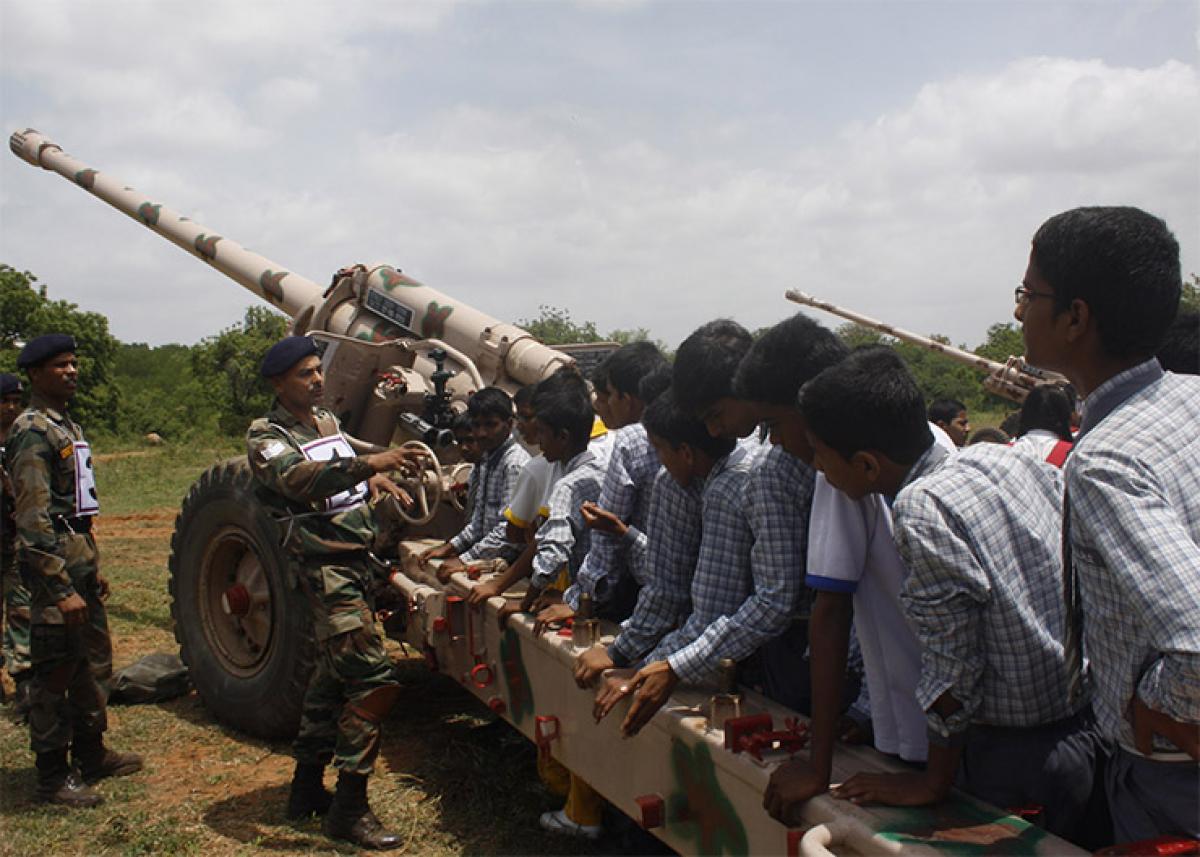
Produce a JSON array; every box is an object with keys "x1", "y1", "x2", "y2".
[{"x1": 5, "y1": 334, "x2": 142, "y2": 807}]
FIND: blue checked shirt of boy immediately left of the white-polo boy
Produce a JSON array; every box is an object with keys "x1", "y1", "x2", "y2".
[{"x1": 667, "y1": 445, "x2": 816, "y2": 683}]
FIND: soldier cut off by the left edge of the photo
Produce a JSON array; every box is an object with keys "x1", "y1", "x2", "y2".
[{"x1": 0, "y1": 372, "x2": 30, "y2": 719}]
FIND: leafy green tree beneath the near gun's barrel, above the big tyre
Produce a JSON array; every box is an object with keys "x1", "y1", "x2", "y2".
[{"x1": 192, "y1": 306, "x2": 289, "y2": 436}]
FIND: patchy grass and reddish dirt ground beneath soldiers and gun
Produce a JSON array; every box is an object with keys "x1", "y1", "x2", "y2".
[{"x1": 0, "y1": 442, "x2": 653, "y2": 855}]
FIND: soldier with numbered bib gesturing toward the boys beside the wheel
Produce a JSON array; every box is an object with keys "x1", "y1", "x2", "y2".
[{"x1": 246, "y1": 336, "x2": 422, "y2": 849}]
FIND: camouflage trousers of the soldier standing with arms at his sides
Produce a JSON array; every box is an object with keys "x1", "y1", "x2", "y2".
[{"x1": 29, "y1": 573, "x2": 113, "y2": 753}]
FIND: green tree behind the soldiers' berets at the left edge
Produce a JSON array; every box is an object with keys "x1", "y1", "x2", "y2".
[{"x1": 0, "y1": 263, "x2": 121, "y2": 433}]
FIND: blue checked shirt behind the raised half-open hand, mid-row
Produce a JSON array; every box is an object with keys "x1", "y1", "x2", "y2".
[{"x1": 563, "y1": 422, "x2": 660, "y2": 610}]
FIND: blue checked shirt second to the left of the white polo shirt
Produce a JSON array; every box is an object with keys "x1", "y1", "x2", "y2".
[{"x1": 646, "y1": 447, "x2": 755, "y2": 681}]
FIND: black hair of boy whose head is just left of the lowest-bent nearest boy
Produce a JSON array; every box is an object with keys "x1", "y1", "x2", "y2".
[{"x1": 733, "y1": 312, "x2": 850, "y2": 407}]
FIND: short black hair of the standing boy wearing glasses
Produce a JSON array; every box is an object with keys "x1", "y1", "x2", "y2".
[{"x1": 1031, "y1": 206, "x2": 1183, "y2": 359}]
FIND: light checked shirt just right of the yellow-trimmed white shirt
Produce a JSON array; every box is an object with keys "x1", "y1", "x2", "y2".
[{"x1": 532, "y1": 449, "x2": 604, "y2": 589}]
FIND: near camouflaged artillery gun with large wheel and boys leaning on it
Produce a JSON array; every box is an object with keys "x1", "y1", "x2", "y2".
[{"x1": 10, "y1": 131, "x2": 1082, "y2": 856}]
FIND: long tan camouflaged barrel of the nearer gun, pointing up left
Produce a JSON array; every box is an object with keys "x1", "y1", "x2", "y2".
[{"x1": 8, "y1": 128, "x2": 574, "y2": 389}]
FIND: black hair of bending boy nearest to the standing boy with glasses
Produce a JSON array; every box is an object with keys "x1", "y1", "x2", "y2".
[{"x1": 799, "y1": 346, "x2": 934, "y2": 465}]
